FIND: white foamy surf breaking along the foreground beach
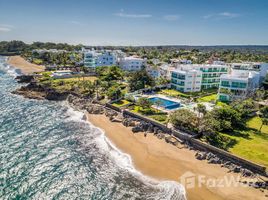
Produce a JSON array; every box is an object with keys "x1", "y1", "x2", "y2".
[{"x1": 62, "y1": 101, "x2": 186, "y2": 200}]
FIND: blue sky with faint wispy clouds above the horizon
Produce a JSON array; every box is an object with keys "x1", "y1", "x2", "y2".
[{"x1": 0, "y1": 0, "x2": 268, "y2": 45}]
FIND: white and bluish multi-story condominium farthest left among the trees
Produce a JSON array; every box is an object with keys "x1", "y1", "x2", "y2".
[{"x1": 84, "y1": 51, "x2": 117, "y2": 68}]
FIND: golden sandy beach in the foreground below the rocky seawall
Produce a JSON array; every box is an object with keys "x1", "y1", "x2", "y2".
[{"x1": 87, "y1": 114, "x2": 267, "y2": 200}]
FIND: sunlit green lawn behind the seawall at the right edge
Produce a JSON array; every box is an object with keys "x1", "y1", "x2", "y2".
[{"x1": 224, "y1": 117, "x2": 268, "y2": 167}]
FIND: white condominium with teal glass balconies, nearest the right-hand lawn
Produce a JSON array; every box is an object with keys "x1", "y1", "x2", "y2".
[{"x1": 218, "y1": 69, "x2": 260, "y2": 101}]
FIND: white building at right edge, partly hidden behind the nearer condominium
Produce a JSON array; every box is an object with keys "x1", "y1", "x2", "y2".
[{"x1": 230, "y1": 62, "x2": 268, "y2": 81}]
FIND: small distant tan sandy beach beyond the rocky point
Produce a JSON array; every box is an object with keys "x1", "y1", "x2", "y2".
[{"x1": 8, "y1": 56, "x2": 45, "y2": 74}]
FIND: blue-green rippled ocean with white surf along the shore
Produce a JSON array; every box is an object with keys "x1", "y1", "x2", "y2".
[{"x1": 0, "y1": 57, "x2": 185, "y2": 200}]
